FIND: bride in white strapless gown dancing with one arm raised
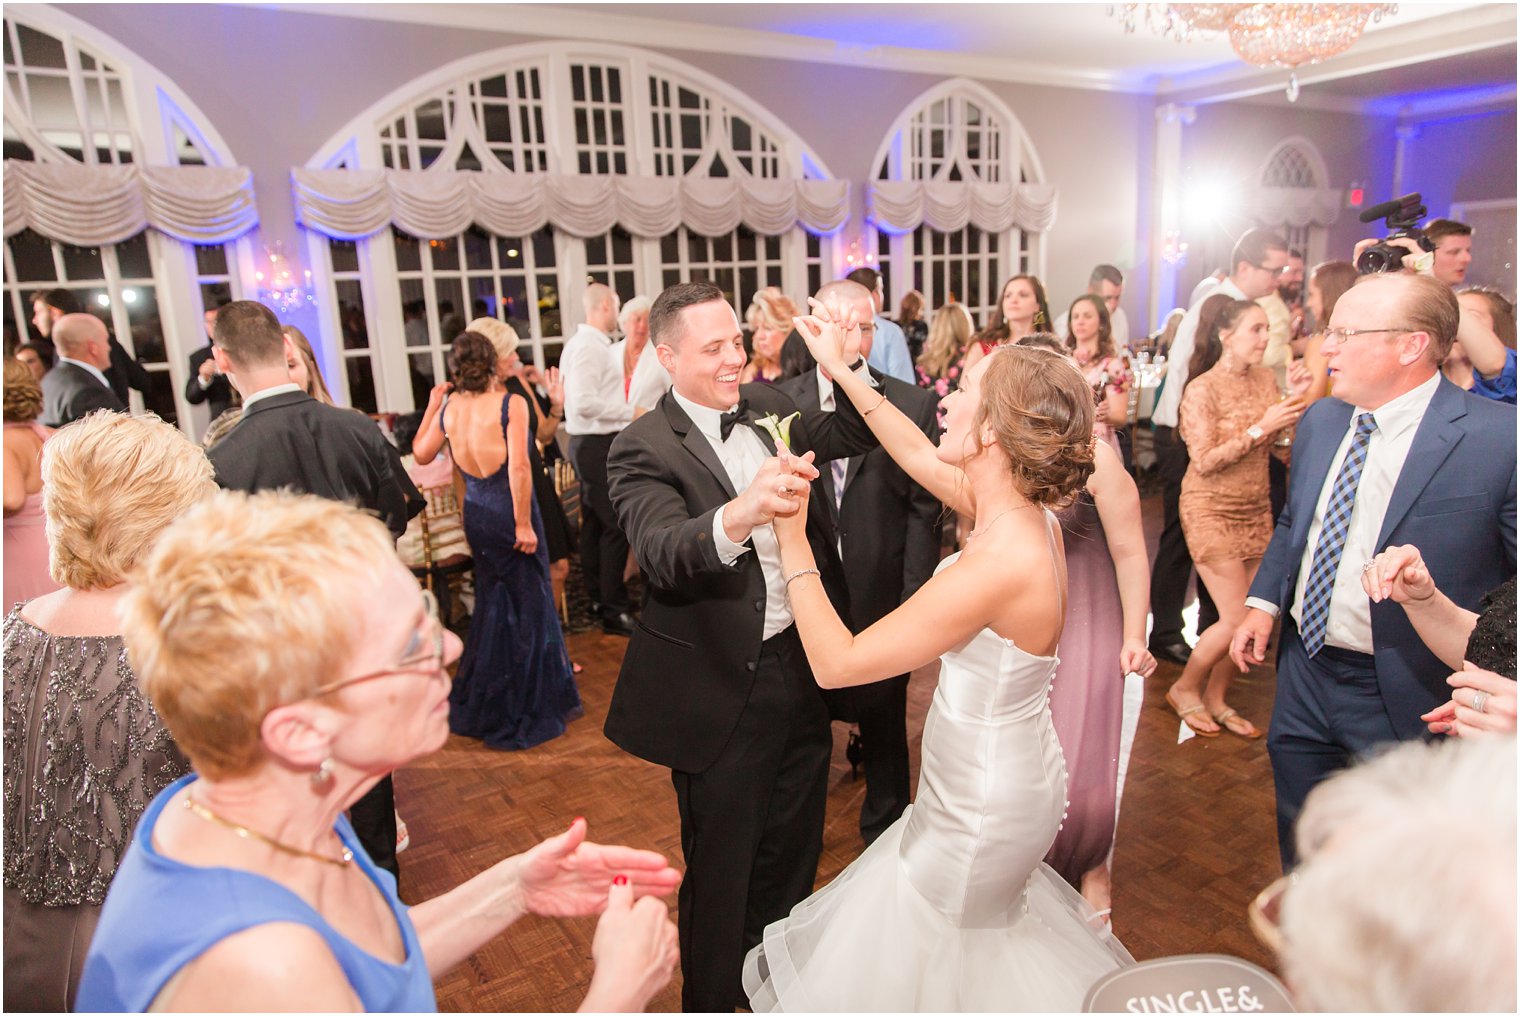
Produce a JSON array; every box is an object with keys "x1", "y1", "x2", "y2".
[{"x1": 743, "y1": 304, "x2": 1132, "y2": 1011}]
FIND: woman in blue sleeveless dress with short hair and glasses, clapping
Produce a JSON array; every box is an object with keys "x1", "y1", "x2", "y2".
[{"x1": 74, "y1": 491, "x2": 681, "y2": 1013}]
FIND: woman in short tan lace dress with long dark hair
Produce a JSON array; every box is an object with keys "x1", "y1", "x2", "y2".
[{"x1": 1166, "y1": 294, "x2": 1309, "y2": 738}]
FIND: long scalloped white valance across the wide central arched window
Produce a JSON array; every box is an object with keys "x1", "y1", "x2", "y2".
[{"x1": 290, "y1": 167, "x2": 850, "y2": 240}]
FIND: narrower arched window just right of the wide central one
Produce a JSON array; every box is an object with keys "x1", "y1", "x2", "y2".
[{"x1": 876, "y1": 79, "x2": 1043, "y2": 325}]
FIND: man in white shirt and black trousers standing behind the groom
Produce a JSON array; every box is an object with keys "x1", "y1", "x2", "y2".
[{"x1": 559, "y1": 283, "x2": 634, "y2": 636}]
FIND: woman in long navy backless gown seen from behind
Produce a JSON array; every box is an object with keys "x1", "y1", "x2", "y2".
[{"x1": 412, "y1": 332, "x2": 581, "y2": 750}]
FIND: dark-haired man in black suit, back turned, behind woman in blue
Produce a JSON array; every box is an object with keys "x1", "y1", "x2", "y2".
[{"x1": 208, "y1": 300, "x2": 423, "y2": 875}]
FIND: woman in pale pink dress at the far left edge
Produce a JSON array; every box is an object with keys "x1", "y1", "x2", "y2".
[{"x1": 5, "y1": 357, "x2": 58, "y2": 613}]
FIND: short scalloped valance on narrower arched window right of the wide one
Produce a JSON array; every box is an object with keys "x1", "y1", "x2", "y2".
[{"x1": 866, "y1": 179, "x2": 1055, "y2": 233}]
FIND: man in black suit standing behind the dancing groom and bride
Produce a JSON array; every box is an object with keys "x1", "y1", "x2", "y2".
[{"x1": 780, "y1": 280, "x2": 942, "y2": 843}]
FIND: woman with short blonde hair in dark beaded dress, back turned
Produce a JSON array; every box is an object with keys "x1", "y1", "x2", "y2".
[{"x1": 5, "y1": 411, "x2": 216, "y2": 1011}]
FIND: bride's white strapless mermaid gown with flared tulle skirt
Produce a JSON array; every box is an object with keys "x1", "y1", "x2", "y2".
[{"x1": 743, "y1": 557, "x2": 1132, "y2": 1013}]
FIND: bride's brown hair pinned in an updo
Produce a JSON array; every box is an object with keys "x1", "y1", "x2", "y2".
[{"x1": 971, "y1": 345, "x2": 1094, "y2": 508}]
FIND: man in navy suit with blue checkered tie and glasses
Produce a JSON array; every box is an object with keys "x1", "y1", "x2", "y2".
[{"x1": 1230, "y1": 272, "x2": 1515, "y2": 867}]
